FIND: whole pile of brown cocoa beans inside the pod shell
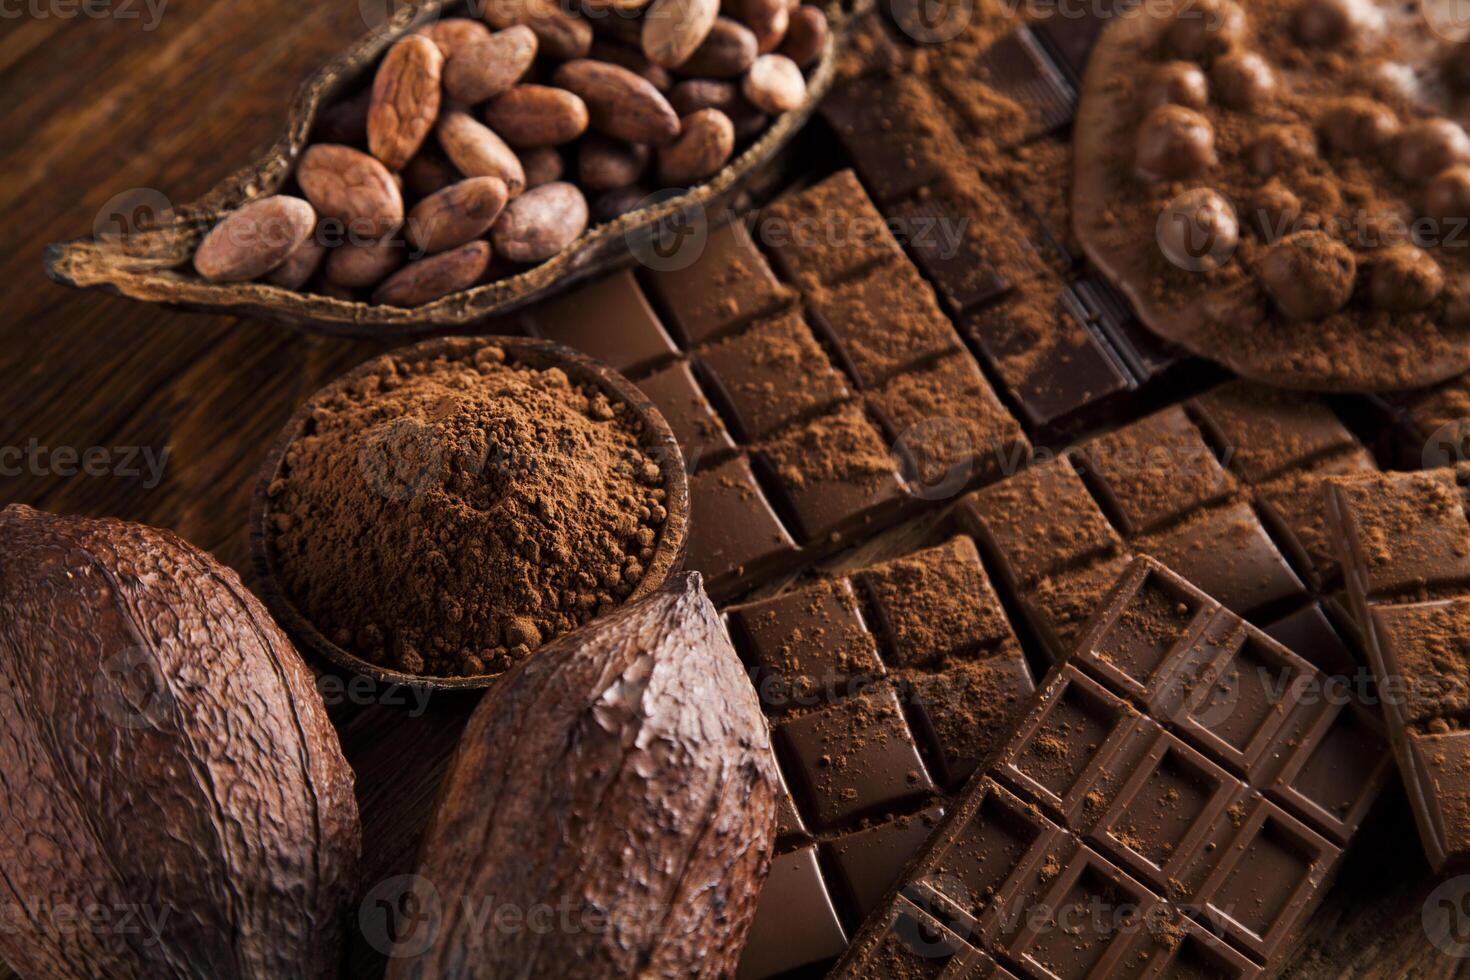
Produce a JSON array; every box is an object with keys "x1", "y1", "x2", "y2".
[{"x1": 194, "y1": 0, "x2": 828, "y2": 307}]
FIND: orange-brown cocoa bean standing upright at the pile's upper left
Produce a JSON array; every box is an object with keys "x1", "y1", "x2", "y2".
[{"x1": 368, "y1": 34, "x2": 444, "y2": 170}]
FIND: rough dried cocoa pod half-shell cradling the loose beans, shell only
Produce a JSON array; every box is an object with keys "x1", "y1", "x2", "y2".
[{"x1": 46, "y1": 0, "x2": 852, "y2": 338}]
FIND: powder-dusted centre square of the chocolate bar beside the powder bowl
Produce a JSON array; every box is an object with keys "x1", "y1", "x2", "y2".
[{"x1": 698, "y1": 311, "x2": 848, "y2": 441}]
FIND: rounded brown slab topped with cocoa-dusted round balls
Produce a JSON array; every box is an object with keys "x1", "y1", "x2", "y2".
[{"x1": 1073, "y1": 0, "x2": 1470, "y2": 391}]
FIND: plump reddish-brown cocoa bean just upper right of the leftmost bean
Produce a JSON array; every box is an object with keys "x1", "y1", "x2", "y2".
[{"x1": 295, "y1": 143, "x2": 403, "y2": 238}]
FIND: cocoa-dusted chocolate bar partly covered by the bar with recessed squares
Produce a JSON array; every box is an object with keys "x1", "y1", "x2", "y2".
[{"x1": 958, "y1": 382, "x2": 1376, "y2": 674}]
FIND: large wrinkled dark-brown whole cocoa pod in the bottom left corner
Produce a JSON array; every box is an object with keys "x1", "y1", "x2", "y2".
[{"x1": 0, "y1": 505, "x2": 360, "y2": 980}]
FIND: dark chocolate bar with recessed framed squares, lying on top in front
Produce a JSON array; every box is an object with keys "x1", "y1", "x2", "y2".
[{"x1": 833, "y1": 558, "x2": 1392, "y2": 980}]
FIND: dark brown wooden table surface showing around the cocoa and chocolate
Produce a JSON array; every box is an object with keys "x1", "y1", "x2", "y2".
[{"x1": 0, "y1": 0, "x2": 1470, "y2": 979}]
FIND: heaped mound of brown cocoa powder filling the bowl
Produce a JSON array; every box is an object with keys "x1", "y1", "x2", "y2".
[{"x1": 269, "y1": 345, "x2": 667, "y2": 676}]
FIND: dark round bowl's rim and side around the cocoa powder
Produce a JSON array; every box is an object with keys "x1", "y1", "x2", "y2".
[{"x1": 250, "y1": 336, "x2": 689, "y2": 691}]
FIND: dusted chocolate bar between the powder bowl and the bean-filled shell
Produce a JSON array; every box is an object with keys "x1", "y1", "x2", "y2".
[{"x1": 526, "y1": 172, "x2": 1029, "y2": 599}]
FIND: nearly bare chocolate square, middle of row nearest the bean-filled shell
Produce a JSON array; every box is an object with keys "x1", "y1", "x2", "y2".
[{"x1": 645, "y1": 220, "x2": 792, "y2": 347}]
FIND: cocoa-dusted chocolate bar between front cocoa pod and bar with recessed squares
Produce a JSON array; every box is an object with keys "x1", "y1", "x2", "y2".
[{"x1": 726, "y1": 536, "x2": 1033, "y2": 979}]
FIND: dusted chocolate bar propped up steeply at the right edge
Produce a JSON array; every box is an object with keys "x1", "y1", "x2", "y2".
[{"x1": 1329, "y1": 467, "x2": 1470, "y2": 871}]
